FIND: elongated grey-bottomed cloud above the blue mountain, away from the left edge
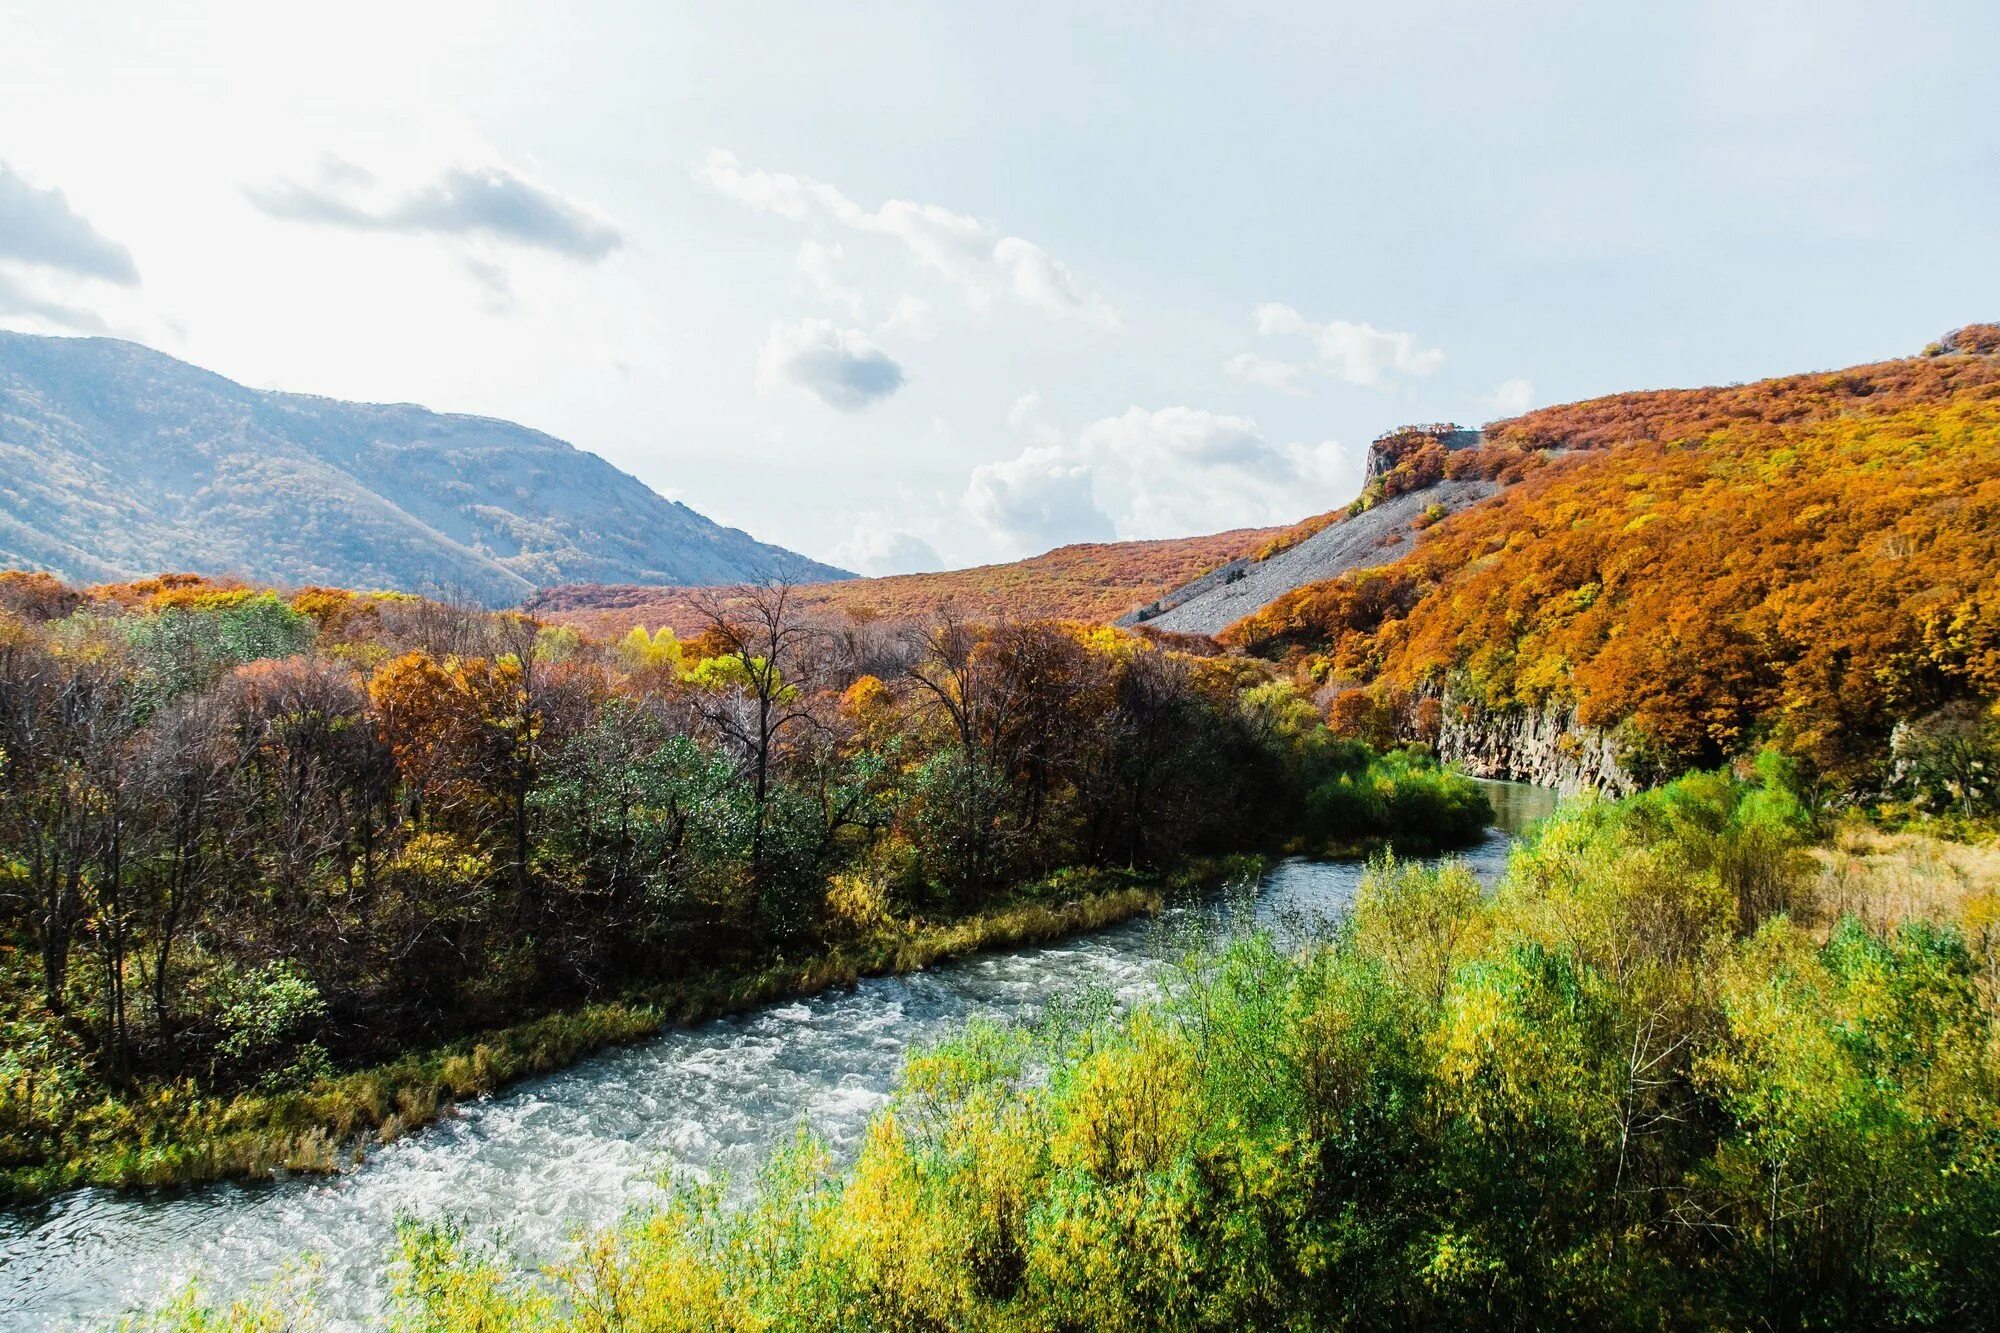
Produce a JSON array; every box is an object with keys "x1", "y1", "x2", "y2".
[{"x1": 244, "y1": 158, "x2": 624, "y2": 264}]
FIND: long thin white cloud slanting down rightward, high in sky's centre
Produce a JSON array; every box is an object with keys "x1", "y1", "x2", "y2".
[{"x1": 694, "y1": 150, "x2": 1118, "y2": 328}]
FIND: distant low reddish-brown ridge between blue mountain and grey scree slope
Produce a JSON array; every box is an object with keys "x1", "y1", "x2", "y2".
[{"x1": 530, "y1": 528, "x2": 1284, "y2": 634}]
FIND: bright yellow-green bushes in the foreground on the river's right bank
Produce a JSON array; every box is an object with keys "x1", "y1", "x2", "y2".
[{"x1": 376, "y1": 763, "x2": 2000, "y2": 1331}]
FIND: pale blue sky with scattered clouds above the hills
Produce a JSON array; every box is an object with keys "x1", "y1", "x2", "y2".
[{"x1": 0, "y1": 0, "x2": 2000, "y2": 574}]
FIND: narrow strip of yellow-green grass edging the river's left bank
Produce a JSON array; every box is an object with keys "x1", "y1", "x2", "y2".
[{"x1": 0, "y1": 857, "x2": 1260, "y2": 1201}]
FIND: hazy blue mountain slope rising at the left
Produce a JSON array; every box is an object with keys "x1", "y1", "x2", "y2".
[{"x1": 0, "y1": 332, "x2": 850, "y2": 604}]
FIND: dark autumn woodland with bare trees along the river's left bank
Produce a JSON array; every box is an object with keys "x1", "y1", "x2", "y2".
[{"x1": 0, "y1": 574, "x2": 1486, "y2": 1175}]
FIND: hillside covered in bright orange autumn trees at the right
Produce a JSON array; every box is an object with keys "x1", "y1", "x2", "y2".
[{"x1": 1224, "y1": 326, "x2": 2000, "y2": 789}]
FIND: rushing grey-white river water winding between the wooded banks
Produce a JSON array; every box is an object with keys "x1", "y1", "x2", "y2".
[{"x1": 0, "y1": 783, "x2": 1554, "y2": 1329}]
